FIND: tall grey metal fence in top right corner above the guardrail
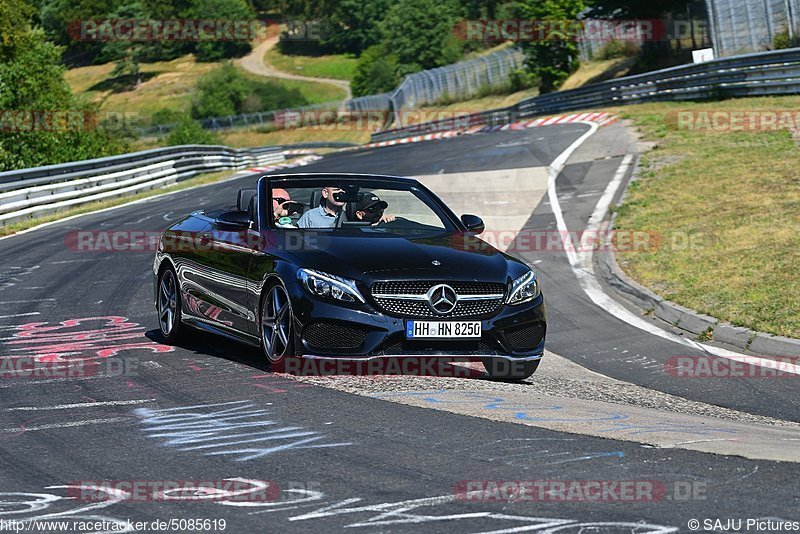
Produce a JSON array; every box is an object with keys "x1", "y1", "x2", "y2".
[{"x1": 706, "y1": 0, "x2": 800, "y2": 57}]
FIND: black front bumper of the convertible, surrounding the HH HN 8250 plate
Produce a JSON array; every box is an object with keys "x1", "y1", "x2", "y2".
[{"x1": 287, "y1": 284, "x2": 547, "y2": 360}]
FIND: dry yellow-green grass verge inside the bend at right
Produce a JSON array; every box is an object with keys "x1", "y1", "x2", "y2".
[{"x1": 616, "y1": 97, "x2": 800, "y2": 338}]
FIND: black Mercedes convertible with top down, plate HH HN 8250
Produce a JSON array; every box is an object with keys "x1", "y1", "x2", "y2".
[{"x1": 153, "y1": 173, "x2": 546, "y2": 380}]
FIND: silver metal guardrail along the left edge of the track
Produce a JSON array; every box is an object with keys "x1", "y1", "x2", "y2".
[{"x1": 0, "y1": 143, "x2": 290, "y2": 226}]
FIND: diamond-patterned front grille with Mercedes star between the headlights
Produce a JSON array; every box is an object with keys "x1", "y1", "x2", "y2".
[{"x1": 371, "y1": 280, "x2": 506, "y2": 319}]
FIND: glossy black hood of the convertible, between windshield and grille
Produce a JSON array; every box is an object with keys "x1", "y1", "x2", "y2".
[{"x1": 274, "y1": 232, "x2": 527, "y2": 283}]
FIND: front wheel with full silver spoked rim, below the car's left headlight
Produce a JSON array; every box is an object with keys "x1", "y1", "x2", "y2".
[{"x1": 259, "y1": 283, "x2": 294, "y2": 367}]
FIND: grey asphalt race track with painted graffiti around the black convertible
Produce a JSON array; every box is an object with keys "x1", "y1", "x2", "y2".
[{"x1": 0, "y1": 124, "x2": 800, "y2": 533}]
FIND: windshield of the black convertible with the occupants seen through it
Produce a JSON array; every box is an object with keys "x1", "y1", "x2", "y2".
[{"x1": 268, "y1": 178, "x2": 456, "y2": 235}]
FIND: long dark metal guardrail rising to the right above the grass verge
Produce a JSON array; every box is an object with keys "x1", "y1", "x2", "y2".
[{"x1": 372, "y1": 48, "x2": 800, "y2": 141}]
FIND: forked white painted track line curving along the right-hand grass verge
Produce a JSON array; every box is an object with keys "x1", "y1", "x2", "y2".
[{"x1": 547, "y1": 122, "x2": 800, "y2": 375}]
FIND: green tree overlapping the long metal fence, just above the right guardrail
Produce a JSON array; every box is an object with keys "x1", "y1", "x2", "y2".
[{"x1": 518, "y1": 0, "x2": 586, "y2": 93}]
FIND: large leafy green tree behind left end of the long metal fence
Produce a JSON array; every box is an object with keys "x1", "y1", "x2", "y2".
[{"x1": 383, "y1": 0, "x2": 462, "y2": 76}]
